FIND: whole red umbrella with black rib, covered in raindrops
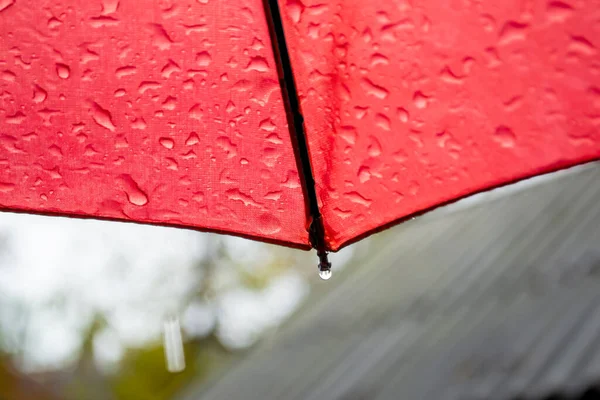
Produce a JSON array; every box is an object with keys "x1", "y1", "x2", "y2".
[{"x1": 0, "y1": 0, "x2": 600, "y2": 276}]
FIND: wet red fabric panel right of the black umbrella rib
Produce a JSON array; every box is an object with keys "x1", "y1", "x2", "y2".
[{"x1": 285, "y1": 0, "x2": 600, "y2": 249}]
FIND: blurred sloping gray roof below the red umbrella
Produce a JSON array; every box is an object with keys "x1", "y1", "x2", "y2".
[{"x1": 183, "y1": 164, "x2": 600, "y2": 400}]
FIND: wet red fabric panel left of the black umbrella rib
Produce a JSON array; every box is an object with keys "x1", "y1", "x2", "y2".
[{"x1": 0, "y1": 0, "x2": 308, "y2": 247}]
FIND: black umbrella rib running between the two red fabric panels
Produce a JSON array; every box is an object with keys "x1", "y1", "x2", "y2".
[{"x1": 263, "y1": 0, "x2": 331, "y2": 270}]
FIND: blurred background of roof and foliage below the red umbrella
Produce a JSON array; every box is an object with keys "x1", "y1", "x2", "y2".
[{"x1": 0, "y1": 164, "x2": 600, "y2": 400}]
